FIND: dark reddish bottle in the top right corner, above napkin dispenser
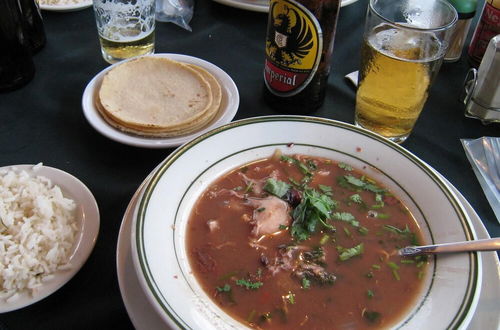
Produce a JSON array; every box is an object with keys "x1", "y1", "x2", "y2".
[{"x1": 468, "y1": 0, "x2": 500, "y2": 67}]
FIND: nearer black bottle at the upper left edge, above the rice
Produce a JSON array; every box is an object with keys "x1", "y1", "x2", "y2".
[{"x1": 0, "y1": 0, "x2": 35, "y2": 92}]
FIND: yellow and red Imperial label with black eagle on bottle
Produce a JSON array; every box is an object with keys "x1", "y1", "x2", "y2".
[{"x1": 264, "y1": 0, "x2": 323, "y2": 97}]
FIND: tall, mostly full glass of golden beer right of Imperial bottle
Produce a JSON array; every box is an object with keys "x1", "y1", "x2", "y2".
[{"x1": 355, "y1": 0, "x2": 458, "y2": 143}]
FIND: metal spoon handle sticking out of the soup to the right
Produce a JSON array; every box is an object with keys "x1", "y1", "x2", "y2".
[{"x1": 398, "y1": 237, "x2": 500, "y2": 256}]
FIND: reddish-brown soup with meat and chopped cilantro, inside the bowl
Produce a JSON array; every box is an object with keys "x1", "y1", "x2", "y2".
[{"x1": 186, "y1": 155, "x2": 427, "y2": 329}]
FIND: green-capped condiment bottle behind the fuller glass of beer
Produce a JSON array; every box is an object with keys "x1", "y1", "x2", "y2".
[{"x1": 444, "y1": 0, "x2": 477, "y2": 62}]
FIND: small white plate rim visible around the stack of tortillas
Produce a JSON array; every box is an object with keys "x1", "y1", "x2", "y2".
[{"x1": 82, "y1": 54, "x2": 240, "y2": 148}]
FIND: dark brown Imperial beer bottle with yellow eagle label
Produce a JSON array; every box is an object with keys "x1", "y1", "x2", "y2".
[{"x1": 263, "y1": 0, "x2": 340, "y2": 114}]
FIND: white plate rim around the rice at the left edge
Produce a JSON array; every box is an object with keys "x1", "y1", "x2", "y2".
[{"x1": 0, "y1": 165, "x2": 99, "y2": 313}]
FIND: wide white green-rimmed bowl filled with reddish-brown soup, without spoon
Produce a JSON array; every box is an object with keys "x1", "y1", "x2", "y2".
[{"x1": 132, "y1": 116, "x2": 481, "y2": 329}]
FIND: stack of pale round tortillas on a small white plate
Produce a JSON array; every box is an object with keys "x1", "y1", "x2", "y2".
[{"x1": 96, "y1": 56, "x2": 222, "y2": 137}]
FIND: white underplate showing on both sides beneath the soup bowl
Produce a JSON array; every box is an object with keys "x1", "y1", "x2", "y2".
[{"x1": 116, "y1": 162, "x2": 500, "y2": 330}]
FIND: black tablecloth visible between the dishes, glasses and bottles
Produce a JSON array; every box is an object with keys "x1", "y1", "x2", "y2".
[{"x1": 0, "y1": 0, "x2": 500, "y2": 330}]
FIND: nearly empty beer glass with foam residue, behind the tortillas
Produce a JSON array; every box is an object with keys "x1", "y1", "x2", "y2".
[{"x1": 93, "y1": 0, "x2": 155, "y2": 63}]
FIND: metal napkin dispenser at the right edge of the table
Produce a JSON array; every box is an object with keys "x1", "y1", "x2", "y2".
[{"x1": 464, "y1": 34, "x2": 500, "y2": 124}]
